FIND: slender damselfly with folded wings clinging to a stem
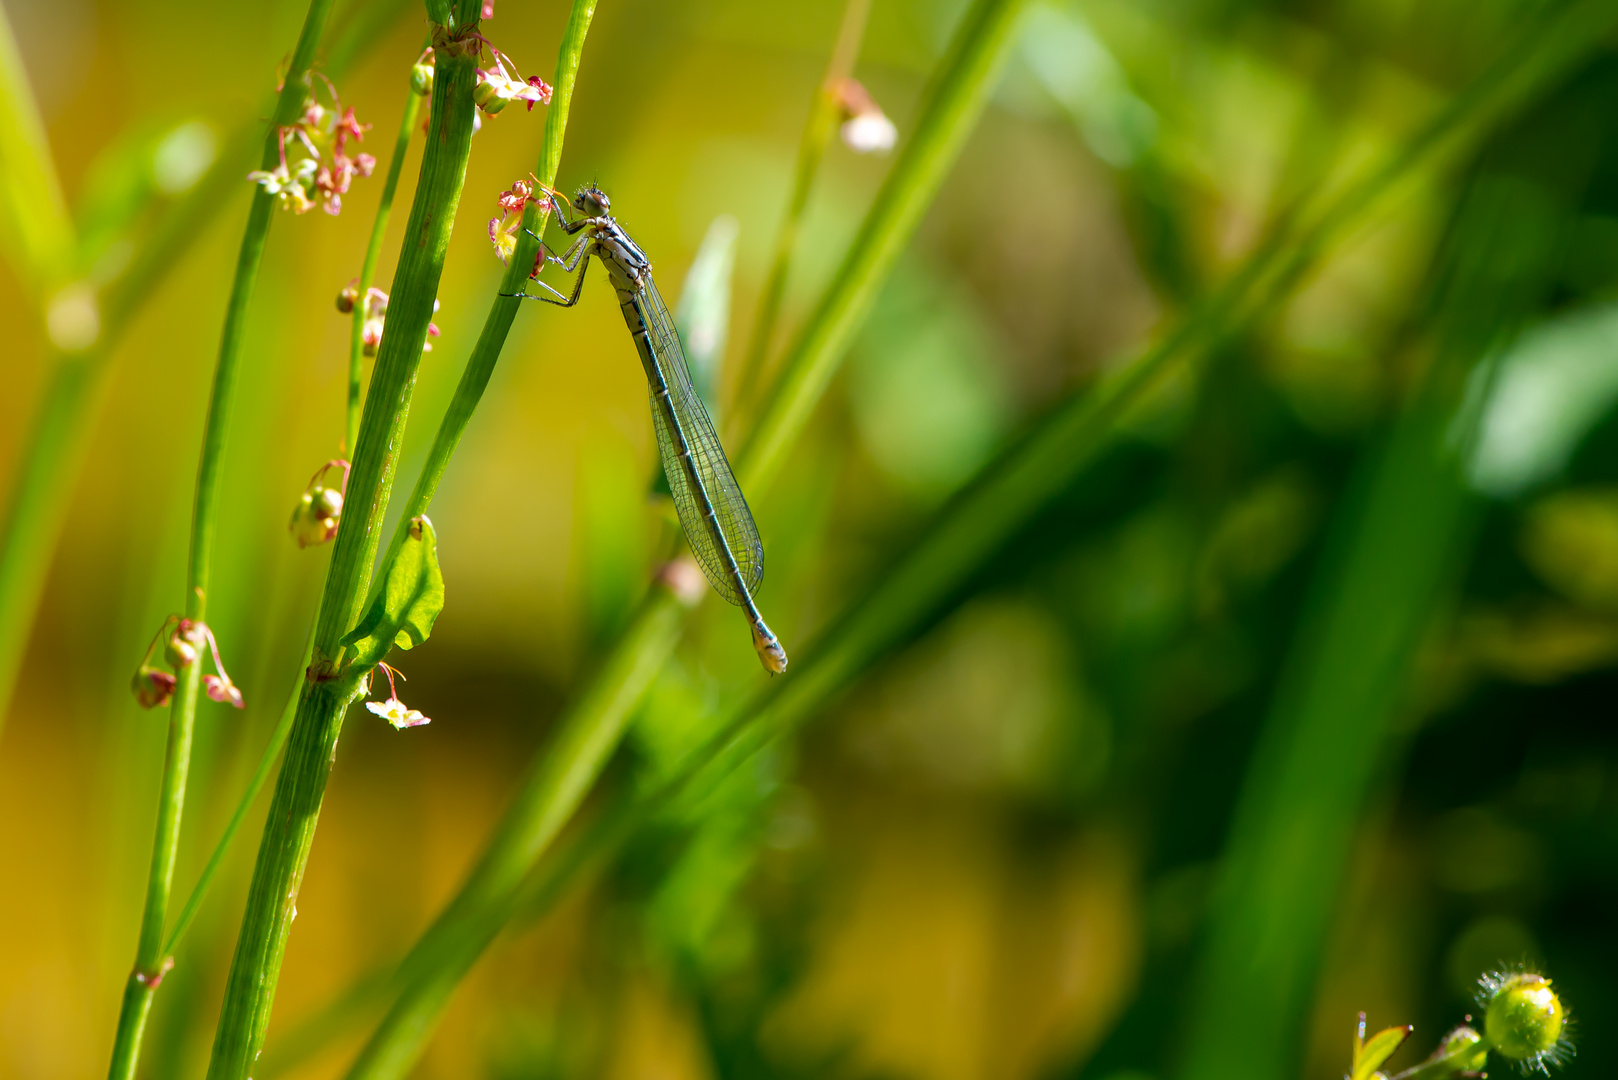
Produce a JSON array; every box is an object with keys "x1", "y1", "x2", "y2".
[{"x1": 508, "y1": 185, "x2": 786, "y2": 674}]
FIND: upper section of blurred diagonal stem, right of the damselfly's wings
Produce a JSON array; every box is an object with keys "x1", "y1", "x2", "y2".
[{"x1": 739, "y1": 0, "x2": 1024, "y2": 492}]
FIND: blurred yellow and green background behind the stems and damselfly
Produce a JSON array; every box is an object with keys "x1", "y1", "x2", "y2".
[{"x1": 0, "y1": 0, "x2": 1618, "y2": 1080}]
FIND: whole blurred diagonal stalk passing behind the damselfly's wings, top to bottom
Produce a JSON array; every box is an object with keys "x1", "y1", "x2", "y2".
[{"x1": 309, "y1": 0, "x2": 1023, "y2": 1080}]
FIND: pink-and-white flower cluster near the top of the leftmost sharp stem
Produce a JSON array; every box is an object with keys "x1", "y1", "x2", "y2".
[{"x1": 248, "y1": 76, "x2": 377, "y2": 214}]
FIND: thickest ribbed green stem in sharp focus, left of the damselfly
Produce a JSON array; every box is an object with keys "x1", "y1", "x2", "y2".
[{"x1": 207, "y1": 33, "x2": 477, "y2": 1080}]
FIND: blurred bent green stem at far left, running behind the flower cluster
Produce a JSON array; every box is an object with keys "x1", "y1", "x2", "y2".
[{"x1": 0, "y1": 0, "x2": 417, "y2": 727}]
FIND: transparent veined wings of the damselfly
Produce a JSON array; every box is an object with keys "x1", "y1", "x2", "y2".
[{"x1": 637, "y1": 277, "x2": 764, "y2": 604}]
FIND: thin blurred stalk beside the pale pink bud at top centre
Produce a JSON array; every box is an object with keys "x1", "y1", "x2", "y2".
[{"x1": 731, "y1": 0, "x2": 870, "y2": 413}]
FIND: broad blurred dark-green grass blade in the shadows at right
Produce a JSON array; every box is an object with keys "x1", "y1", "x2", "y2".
[{"x1": 1181, "y1": 114, "x2": 1571, "y2": 1080}]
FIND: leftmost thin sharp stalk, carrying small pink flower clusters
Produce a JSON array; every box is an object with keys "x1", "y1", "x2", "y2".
[{"x1": 108, "y1": 0, "x2": 332, "y2": 1080}]
